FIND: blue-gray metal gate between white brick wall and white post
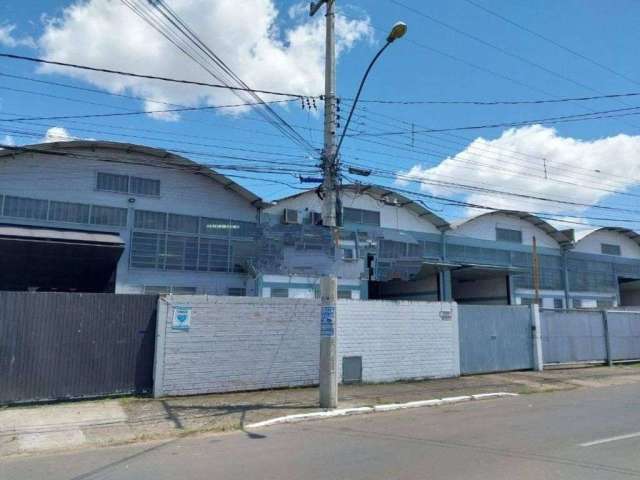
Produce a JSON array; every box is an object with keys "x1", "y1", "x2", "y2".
[{"x1": 458, "y1": 305, "x2": 534, "y2": 374}]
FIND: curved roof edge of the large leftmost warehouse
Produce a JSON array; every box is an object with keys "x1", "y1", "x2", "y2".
[{"x1": 0, "y1": 140, "x2": 264, "y2": 207}]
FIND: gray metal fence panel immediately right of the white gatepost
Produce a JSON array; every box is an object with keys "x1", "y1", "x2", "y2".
[{"x1": 540, "y1": 310, "x2": 607, "y2": 364}]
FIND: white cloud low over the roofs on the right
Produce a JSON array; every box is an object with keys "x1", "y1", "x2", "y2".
[{"x1": 397, "y1": 125, "x2": 640, "y2": 219}]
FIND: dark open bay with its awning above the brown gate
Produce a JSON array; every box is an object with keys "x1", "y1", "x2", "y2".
[{"x1": 0, "y1": 225, "x2": 124, "y2": 292}]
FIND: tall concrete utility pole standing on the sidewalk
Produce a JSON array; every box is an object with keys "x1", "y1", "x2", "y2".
[{"x1": 310, "y1": 0, "x2": 338, "y2": 408}]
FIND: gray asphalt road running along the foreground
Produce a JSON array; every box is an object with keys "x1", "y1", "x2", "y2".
[{"x1": 0, "y1": 384, "x2": 640, "y2": 480}]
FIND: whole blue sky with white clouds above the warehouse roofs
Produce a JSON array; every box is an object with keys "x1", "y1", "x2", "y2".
[{"x1": 0, "y1": 0, "x2": 640, "y2": 230}]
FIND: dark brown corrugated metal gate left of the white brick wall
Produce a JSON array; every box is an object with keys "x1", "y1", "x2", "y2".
[{"x1": 0, "y1": 292, "x2": 157, "y2": 404}]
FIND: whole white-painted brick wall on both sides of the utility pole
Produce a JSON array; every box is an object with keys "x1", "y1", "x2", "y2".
[{"x1": 154, "y1": 296, "x2": 460, "y2": 396}]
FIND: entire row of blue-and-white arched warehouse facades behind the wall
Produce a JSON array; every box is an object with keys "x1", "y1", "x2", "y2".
[{"x1": 0, "y1": 141, "x2": 640, "y2": 308}]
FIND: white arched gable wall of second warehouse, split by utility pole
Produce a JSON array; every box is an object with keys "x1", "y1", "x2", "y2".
[{"x1": 265, "y1": 190, "x2": 440, "y2": 234}]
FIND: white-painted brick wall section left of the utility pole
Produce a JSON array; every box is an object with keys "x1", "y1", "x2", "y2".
[{"x1": 154, "y1": 296, "x2": 320, "y2": 396}]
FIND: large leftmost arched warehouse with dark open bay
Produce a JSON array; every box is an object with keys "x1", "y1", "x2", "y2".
[{"x1": 0, "y1": 141, "x2": 262, "y2": 295}]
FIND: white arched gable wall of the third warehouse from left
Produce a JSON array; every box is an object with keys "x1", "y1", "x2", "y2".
[{"x1": 451, "y1": 213, "x2": 560, "y2": 248}]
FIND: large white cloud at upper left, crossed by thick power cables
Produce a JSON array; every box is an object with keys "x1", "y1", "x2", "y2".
[{"x1": 38, "y1": 0, "x2": 373, "y2": 120}]
